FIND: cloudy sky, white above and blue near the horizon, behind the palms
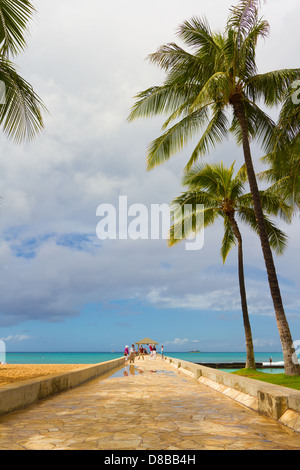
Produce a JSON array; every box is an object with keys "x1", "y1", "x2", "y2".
[{"x1": 0, "y1": 0, "x2": 300, "y2": 352}]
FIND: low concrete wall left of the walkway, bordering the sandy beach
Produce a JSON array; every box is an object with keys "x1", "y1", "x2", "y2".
[{"x1": 0, "y1": 357, "x2": 125, "y2": 416}]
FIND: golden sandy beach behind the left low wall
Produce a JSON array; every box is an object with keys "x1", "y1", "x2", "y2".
[{"x1": 0, "y1": 364, "x2": 90, "y2": 387}]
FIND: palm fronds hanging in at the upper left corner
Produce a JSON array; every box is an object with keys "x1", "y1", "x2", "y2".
[{"x1": 0, "y1": 0, "x2": 46, "y2": 143}]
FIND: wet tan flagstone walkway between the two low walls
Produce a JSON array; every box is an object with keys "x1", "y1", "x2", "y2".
[{"x1": 0, "y1": 358, "x2": 300, "y2": 450}]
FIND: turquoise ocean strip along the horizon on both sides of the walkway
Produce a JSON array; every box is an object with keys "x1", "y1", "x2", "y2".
[{"x1": 3, "y1": 349, "x2": 284, "y2": 373}]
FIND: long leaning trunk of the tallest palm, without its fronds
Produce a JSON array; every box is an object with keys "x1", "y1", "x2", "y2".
[{"x1": 231, "y1": 95, "x2": 300, "y2": 375}]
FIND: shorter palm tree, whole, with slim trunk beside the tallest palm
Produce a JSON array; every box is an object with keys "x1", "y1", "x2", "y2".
[{"x1": 169, "y1": 163, "x2": 292, "y2": 369}]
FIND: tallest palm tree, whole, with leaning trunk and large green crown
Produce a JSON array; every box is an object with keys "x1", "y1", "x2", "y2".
[{"x1": 128, "y1": 0, "x2": 300, "y2": 375}]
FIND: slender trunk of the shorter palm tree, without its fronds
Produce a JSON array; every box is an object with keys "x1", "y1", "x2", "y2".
[{"x1": 228, "y1": 213, "x2": 256, "y2": 369}]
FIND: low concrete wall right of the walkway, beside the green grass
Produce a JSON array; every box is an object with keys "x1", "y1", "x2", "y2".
[{"x1": 165, "y1": 357, "x2": 300, "y2": 432}]
